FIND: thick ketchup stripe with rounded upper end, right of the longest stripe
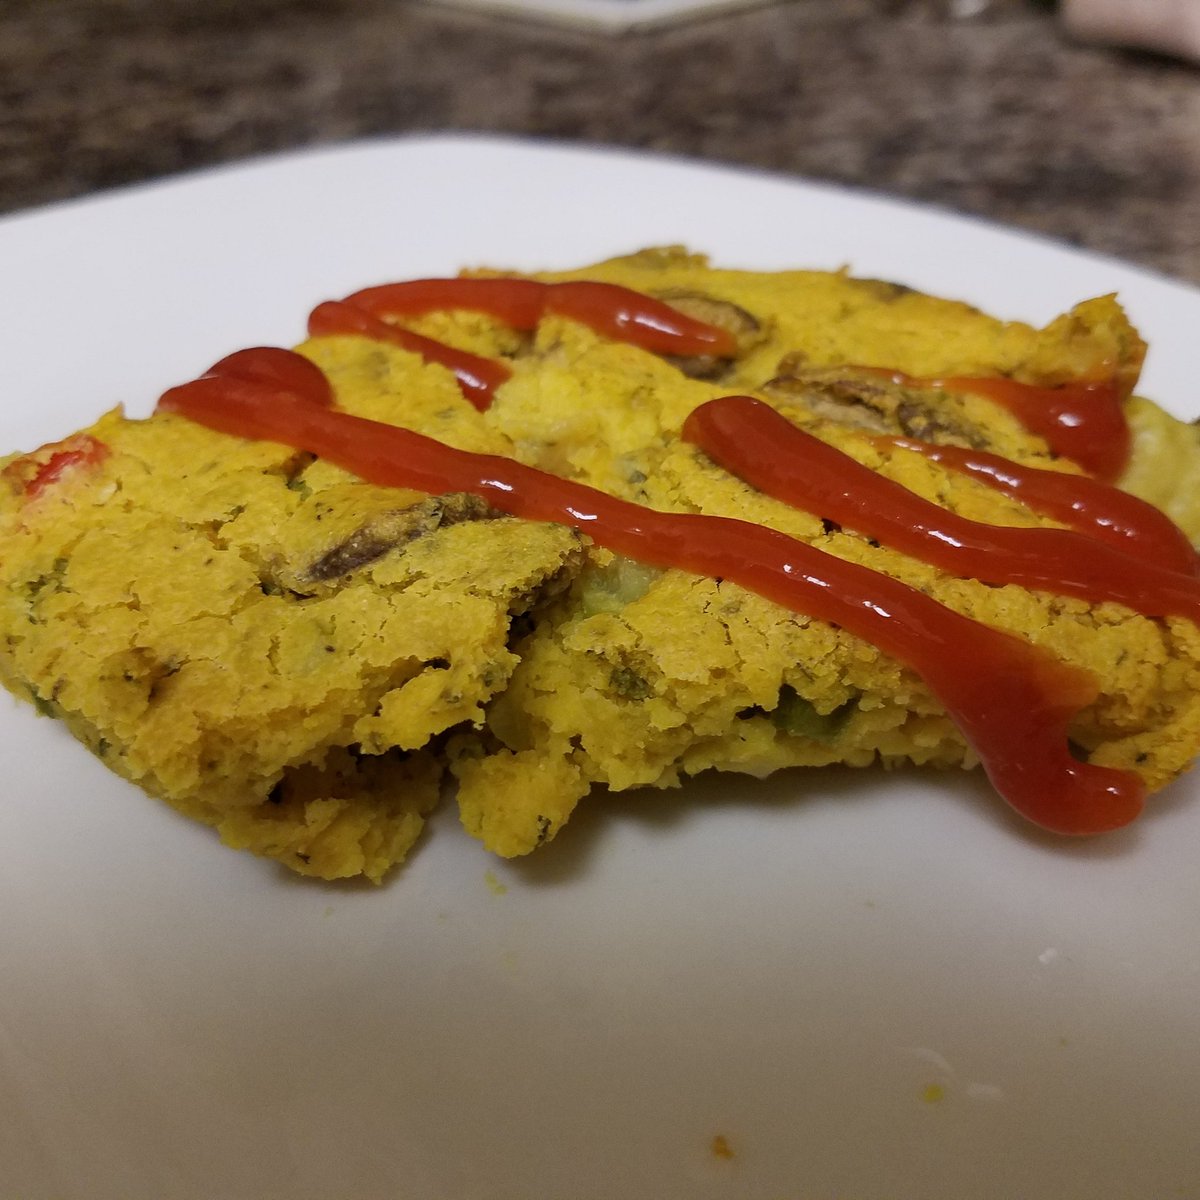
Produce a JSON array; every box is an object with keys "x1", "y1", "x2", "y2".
[{"x1": 683, "y1": 396, "x2": 1200, "y2": 623}]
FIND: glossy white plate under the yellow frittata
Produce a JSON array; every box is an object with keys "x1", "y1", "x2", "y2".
[{"x1": 0, "y1": 138, "x2": 1200, "y2": 1200}]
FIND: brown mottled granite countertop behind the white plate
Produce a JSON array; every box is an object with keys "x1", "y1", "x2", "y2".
[{"x1": 7, "y1": 0, "x2": 1200, "y2": 283}]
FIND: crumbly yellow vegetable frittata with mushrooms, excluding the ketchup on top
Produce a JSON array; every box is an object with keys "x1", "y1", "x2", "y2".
[{"x1": 0, "y1": 248, "x2": 1200, "y2": 881}]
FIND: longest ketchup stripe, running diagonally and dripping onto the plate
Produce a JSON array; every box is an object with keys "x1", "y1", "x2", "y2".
[{"x1": 160, "y1": 357, "x2": 1145, "y2": 834}]
